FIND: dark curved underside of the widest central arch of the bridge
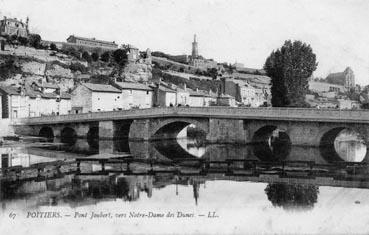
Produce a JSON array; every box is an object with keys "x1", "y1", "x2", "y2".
[{"x1": 149, "y1": 118, "x2": 209, "y2": 139}]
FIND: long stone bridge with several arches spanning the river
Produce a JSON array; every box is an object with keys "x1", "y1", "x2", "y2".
[{"x1": 13, "y1": 107, "x2": 369, "y2": 149}]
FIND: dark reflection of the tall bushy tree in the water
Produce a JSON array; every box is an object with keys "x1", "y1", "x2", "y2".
[{"x1": 265, "y1": 183, "x2": 319, "y2": 210}]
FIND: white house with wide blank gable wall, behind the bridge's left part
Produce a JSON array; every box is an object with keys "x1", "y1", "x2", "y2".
[{"x1": 71, "y1": 83, "x2": 122, "y2": 113}]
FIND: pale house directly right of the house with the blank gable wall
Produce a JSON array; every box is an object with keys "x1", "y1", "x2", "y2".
[{"x1": 114, "y1": 82, "x2": 154, "y2": 109}]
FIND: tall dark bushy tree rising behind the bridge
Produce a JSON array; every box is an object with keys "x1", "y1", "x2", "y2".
[{"x1": 264, "y1": 40, "x2": 318, "y2": 107}]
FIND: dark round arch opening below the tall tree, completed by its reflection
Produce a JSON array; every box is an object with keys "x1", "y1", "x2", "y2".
[{"x1": 252, "y1": 125, "x2": 291, "y2": 161}]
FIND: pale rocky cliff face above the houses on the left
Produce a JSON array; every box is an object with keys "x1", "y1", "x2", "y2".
[{"x1": 0, "y1": 46, "x2": 151, "y2": 91}]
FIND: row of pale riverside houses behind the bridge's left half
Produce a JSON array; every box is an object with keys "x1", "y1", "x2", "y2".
[{"x1": 0, "y1": 81, "x2": 236, "y2": 119}]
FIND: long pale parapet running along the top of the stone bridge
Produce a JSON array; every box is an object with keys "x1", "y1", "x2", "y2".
[{"x1": 14, "y1": 106, "x2": 369, "y2": 125}]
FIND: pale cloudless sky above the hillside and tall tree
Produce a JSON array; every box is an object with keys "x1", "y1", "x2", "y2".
[{"x1": 0, "y1": 0, "x2": 369, "y2": 85}]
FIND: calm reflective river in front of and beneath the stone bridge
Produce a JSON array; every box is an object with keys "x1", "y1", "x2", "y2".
[{"x1": 0, "y1": 133, "x2": 369, "y2": 234}]
